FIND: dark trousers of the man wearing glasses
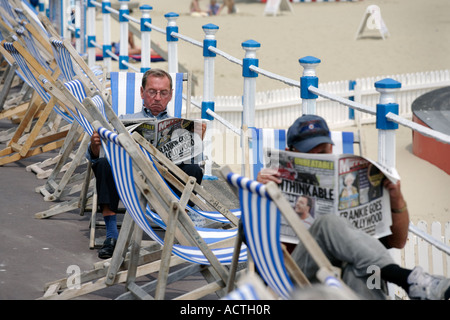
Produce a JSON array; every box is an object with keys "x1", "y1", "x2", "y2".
[{"x1": 92, "y1": 158, "x2": 203, "y2": 212}]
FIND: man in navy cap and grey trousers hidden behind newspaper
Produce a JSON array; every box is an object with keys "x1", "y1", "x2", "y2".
[{"x1": 257, "y1": 115, "x2": 450, "y2": 299}]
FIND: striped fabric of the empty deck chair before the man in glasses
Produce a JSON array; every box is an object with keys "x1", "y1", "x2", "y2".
[{"x1": 98, "y1": 127, "x2": 247, "y2": 264}]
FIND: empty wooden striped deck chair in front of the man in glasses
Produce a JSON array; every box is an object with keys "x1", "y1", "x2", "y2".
[{"x1": 40, "y1": 89, "x2": 246, "y2": 297}]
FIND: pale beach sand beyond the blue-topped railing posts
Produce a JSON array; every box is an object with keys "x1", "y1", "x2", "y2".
[{"x1": 97, "y1": 0, "x2": 450, "y2": 223}]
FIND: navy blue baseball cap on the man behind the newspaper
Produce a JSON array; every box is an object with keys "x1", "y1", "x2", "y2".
[{"x1": 287, "y1": 114, "x2": 334, "y2": 153}]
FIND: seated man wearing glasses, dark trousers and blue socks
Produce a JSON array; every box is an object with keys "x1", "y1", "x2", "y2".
[{"x1": 86, "y1": 69, "x2": 206, "y2": 259}]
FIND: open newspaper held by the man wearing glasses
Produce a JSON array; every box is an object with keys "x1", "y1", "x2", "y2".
[{"x1": 122, "y1": 118, "x2": 203, "y2": 164}]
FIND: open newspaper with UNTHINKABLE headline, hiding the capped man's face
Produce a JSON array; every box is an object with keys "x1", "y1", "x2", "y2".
[{"x1": 265, "y1": 149, "x2": 400, "y2": 243}]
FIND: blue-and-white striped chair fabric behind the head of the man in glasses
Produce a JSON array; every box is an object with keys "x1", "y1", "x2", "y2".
[{"x1": 111, "y1": 72, "x2": 183, "y2": 118}]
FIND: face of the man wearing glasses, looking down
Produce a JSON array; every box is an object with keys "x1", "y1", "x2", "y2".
[{"x1": 141, "y1": 77, "x2": 172, "y2": 116}]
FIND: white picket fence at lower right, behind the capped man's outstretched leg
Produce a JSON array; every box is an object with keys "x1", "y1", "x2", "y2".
[{"x1": 389, "y1": 221, "x2": 450, "y2": 299}]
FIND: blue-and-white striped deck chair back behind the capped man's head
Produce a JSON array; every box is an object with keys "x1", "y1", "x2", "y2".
[{"x1": 247, "y1": 127, "x2": 362, "y2": 179}]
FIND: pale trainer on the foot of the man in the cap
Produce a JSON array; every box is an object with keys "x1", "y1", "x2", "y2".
[{"x1": 408, "y1": 266, "x2": 450, "y2": 300}]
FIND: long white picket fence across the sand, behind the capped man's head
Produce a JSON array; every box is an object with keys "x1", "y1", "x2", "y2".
[{"x1": 191, "y1": 70, "x2": 450, "y2": 130}]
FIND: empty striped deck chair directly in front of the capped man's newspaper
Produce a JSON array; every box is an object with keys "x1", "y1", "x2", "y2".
[{"x1": 222, "y1": 167, "x2": 356, "y2": 299}]
